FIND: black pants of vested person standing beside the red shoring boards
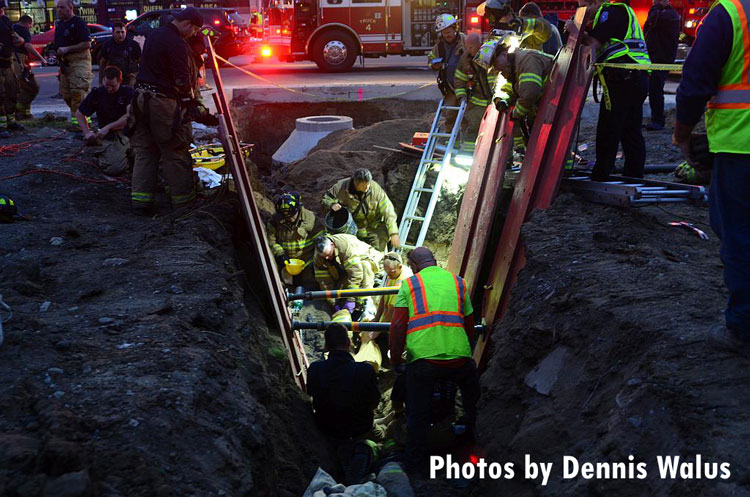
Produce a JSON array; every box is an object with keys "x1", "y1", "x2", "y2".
[{"x1": 591, "y1": 69, "x2": 648, "y2": 181}]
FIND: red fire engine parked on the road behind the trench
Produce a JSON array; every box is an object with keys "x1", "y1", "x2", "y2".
[{"x1": 256, "y1": 0, "x2": 710, "y2": 72}]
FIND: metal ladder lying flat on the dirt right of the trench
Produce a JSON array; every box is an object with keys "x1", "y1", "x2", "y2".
[{"x1": 564, "y1": 176, "x2": 707, "y2": 207}]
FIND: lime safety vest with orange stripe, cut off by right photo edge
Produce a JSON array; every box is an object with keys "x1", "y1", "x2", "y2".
[{"x1": 699, "y1": 0, "x2": 750, "y2": 154}]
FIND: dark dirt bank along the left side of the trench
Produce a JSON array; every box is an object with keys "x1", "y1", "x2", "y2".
[{"x1": 0, "y1": 124, "x2": 335, "y2": 497}]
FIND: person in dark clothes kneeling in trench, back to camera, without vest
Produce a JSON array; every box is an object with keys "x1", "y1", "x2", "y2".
[{"x1": 307, "y1": 323, "x2": 380, "y2": 485}]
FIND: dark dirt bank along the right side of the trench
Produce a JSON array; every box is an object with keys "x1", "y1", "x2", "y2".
[{"x1": 472, "y1": 194, "x2": 750, "y2": 496}]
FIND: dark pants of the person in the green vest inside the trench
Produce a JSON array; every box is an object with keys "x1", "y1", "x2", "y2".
[{"x1": 405, "y1": 359, "x2": 480, "y2": 467}]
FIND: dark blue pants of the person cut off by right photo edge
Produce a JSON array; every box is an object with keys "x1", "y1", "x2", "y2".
[{"x1": 708, "y1": 153, "x2": 750, "y2": 340}]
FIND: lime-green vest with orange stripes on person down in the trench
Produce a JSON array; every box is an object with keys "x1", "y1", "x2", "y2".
[{"x1": 396, "y1": 266, "x2": 474, "y2": 362}]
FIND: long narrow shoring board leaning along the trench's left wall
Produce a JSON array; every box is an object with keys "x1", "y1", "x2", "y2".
[{"x1": 205, "y1": 36, "x2": 308, "y2": 390}]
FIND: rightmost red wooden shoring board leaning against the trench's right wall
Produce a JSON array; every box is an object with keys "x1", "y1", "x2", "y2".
[{"x1": 464, "y1": 8, "x2": 594, "y2": 364}]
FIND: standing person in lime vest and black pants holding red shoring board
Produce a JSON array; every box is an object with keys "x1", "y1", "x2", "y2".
[{"x1": 565, "y1": 0, "x2": 651, "y2": 181}]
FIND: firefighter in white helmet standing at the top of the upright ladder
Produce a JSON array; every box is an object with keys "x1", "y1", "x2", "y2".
[{"x1": 427, "y1": 14, "x2": 466, "y2": 133}]
